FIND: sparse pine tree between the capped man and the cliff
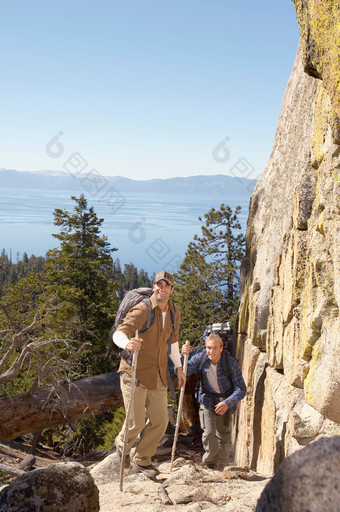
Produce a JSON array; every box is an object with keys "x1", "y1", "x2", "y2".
[{"x1": 174, "y1": 204, "x2": 245, "y2": 344}]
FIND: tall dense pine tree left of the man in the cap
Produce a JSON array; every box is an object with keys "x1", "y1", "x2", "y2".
[{"x1": 45, "y1": 194, "x2": 118, "y2": 374}]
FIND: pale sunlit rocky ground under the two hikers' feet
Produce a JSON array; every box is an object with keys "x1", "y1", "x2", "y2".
[{"x1": 91, "y1": 455, "x2": 269, "y2": 512}]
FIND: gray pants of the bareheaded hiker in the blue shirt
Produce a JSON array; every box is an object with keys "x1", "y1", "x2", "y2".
[{"x1": 199, "y1": 404, "x2": 230, "y2": 464}]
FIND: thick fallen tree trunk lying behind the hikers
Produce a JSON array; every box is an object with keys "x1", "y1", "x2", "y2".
[{"x1": 0, "y1": 372, "x2": 123, "y2": 441}]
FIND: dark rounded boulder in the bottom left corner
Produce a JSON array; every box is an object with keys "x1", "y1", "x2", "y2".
[{"x1": 0, "y1": 462, "x2": 99, "y2": 512}]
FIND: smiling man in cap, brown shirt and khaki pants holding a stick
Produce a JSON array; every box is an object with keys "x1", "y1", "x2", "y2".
[{"x1": 113, "y1": 271, "x2": 185, "y2": 476}]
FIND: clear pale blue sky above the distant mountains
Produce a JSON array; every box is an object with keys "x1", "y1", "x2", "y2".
[{"x1": 0, "y1": 0, "x2": 299, "y2": 179}]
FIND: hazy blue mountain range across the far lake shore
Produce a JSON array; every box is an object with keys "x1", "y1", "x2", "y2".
[{"x1": 0, "y1": 169, "x2": 256, "y2": 196}]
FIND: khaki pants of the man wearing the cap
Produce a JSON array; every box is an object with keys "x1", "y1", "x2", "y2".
[{"x1": 116, "y1": 372, "x2": 169, "y2": 466}]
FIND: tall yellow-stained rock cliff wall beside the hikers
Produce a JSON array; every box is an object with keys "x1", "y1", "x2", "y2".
[{"x1": 233, "y1": 4, "x2": 340, "y2": 475}]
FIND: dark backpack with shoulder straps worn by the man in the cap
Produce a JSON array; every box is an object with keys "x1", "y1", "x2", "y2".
[{"x1": 108, "y1": 288, "x2": 176, "y2": 365}]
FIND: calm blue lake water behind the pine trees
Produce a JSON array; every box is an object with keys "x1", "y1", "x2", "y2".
[{"x1": 0, "y1": 188, "x2": 249, "y2": 274}]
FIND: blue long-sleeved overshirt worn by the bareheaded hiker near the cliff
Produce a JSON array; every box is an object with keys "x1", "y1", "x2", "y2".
[{"x1": 187, "y1": 347, "x2": 247, "y2": 412}]
